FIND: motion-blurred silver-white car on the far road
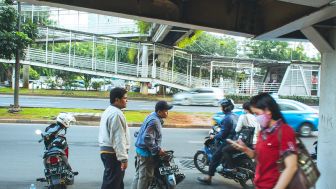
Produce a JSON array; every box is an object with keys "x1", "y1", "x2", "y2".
[{"x1": 173, "y1": 88, "x2": 224, "y2": 106}]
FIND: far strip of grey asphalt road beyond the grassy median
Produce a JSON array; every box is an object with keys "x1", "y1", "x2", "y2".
[{"x1": 0, "y1": 95, "x2": 220, "y2": 113}]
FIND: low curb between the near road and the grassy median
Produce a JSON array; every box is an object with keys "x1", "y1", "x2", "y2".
[{"x1": 0, "y1": 119, "x2": 210, "y2": 129}]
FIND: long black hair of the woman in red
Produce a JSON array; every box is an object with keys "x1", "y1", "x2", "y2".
[{"x1": 250, "y1": 93, "x2": 286, "y2": 123}]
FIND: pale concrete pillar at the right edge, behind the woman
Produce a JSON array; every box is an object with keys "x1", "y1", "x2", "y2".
[{"x1": 317, "y1": 30, "x2": 336, "y2": 189}]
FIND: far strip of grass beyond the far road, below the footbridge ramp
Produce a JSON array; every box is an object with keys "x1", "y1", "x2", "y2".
[{"x1": 0, "y1": 87, "x2": 171, "y2": 101}]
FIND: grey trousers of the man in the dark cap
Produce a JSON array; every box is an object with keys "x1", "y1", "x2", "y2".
[{"x1": 132, "y1": 154, "x2": 157, "y2": 189}]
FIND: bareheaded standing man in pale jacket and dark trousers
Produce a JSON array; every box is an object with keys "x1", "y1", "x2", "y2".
[{"x1": 98, "y1": 87, "x2": 130, "y2": 189}]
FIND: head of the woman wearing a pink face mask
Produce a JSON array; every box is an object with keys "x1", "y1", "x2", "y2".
[{"x1": 250, "y1": 93, "x2": 285, "y2": 127}]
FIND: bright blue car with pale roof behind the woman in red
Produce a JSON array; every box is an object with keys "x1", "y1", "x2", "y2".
[{"x1": 212, "y1": 99, "x2": 319, "y2": 136}]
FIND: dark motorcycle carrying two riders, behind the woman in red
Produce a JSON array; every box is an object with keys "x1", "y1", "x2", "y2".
[{"x1": 194, "y1": 126, "x2": 255, "y2": 189}]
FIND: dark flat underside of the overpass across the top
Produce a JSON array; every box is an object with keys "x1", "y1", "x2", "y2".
[{"x1": 22, "y1": 0, "x2": 317, "y2": 37}]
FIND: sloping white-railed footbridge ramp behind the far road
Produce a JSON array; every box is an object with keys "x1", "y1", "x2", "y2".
[{"x1": 0, "y1": 27, "x2": 210, "y2": 90}]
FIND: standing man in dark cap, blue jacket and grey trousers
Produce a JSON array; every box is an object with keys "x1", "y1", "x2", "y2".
[{"x1": 132, "y1": 101, "x2": 173, "y2": 189}]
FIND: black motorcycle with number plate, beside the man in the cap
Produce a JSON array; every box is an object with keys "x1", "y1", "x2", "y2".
[{"x1": 149, "y1": 151, "x2": 185, "y2": 189}]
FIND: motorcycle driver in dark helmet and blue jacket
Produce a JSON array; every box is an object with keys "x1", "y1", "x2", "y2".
[{"x1": 197, "y1": 99, "x2": 237, "y2": 184}]
